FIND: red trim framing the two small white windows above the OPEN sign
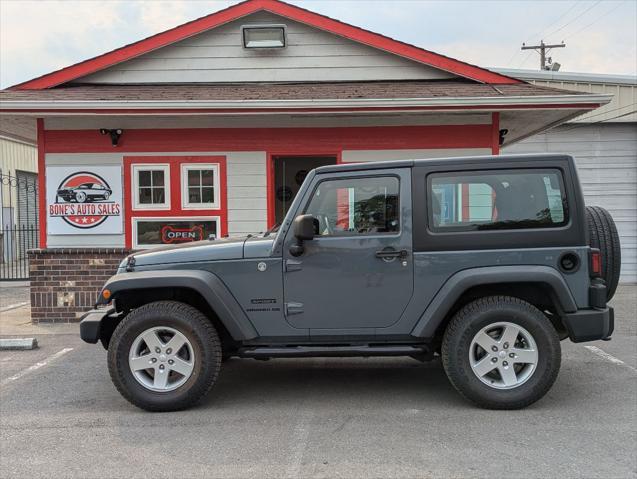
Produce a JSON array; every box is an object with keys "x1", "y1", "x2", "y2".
[{"x1": 124, "y1": 156, "x2": 228, "y2": 248}]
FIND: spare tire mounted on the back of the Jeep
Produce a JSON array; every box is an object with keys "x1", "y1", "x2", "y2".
[{"x1": 586, "y1": 206, "x2": 622, "y2": 300}]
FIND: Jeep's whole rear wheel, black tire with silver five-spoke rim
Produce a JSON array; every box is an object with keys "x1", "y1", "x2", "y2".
[{"x1": 442, "y1": 296, "x2": 561, "y2": 409}]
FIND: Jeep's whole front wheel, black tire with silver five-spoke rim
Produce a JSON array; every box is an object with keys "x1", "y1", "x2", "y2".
[{"x1": 108, "y1": 301, "x2": 221, "y2": 411}]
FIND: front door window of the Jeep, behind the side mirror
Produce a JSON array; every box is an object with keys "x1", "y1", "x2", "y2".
[{"x1": 306, "y1": 176, "x2": 400, "y2": 236}]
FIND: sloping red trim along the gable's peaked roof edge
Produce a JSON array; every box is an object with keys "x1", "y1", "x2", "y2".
[{"x1": 12, "y1": 0, "x2": 522, "y2": 90}]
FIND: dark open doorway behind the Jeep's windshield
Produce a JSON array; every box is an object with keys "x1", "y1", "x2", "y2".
[{"x1": 273, "y1": 156, "x2": 336, "y2": 224}]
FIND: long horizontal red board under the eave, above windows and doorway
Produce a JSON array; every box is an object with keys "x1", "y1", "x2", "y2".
[{"x1": 45, "y1": 124, "x2": 492, "y2": 154}]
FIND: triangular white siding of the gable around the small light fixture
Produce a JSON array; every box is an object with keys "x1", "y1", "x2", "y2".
[{"x1": 76, "y1": 12, "x2": 454, "y2": 83}]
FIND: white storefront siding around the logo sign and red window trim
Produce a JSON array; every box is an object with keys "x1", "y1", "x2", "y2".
[{"x1": 46, "y1": 151, "x2": 267, "y2": 248}]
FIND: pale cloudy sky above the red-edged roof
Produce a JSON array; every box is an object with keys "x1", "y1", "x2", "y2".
[{"x1": 0, "y1": 0, "x2": 637, "y2": 88}]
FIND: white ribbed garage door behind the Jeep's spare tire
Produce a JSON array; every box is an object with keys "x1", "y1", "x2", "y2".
[{"x1": 503, "y1": 123, "x2": 637, "y2": 283}]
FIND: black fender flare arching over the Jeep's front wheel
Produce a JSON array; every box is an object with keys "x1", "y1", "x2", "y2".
[{"x1": 98, "y1": 270, "x2": 258, "y2": 341}]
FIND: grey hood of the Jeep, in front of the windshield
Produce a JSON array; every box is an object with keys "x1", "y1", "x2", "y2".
[{"x1": 131, "y1": 236, "x2": 274, "y2": 267}]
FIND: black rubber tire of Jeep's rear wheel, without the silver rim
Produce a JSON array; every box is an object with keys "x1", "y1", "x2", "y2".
[{"x1": 441, "y1": 296, "x2": 561, "y2": 409}]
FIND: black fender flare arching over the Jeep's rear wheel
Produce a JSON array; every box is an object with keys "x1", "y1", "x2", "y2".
[{"x1": 411, "y1": 266, "x2": 577, "y2": 338}]
